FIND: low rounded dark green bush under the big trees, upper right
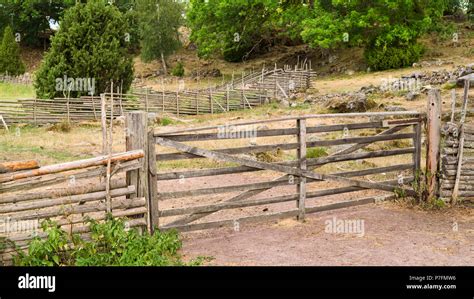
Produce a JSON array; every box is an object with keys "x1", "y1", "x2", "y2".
[{"x1": 365, "y1": 44, "x2": 423, "y2": 70}]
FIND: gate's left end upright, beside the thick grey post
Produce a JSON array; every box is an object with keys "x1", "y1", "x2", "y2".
[{"x1": 147, "y1": 129, "x2": 160, "y2": 233}]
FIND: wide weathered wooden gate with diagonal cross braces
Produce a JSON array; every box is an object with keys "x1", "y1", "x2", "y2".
[{"x1": 121, "y1": 112, "x2": 423, "y2": 231}]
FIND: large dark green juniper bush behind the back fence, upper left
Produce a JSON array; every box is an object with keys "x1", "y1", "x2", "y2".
[{"x1": 35, "y1": 0, "x2": 133, "y2": 98}]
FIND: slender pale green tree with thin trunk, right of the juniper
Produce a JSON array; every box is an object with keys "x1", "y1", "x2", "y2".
[{"x1": 136, "y1": 0, "x2": 183, "y2": 73}]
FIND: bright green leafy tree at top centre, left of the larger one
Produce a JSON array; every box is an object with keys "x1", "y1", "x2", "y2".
[{"x1": 187, "y1": 0, "x2": 279, "y2": 62}]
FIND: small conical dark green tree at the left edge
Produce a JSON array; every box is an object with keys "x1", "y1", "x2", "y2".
[{"x1": 0, "y1": 26, "x2": 25, "y2": 76}]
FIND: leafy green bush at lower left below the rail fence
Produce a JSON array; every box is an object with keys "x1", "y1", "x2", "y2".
[{"x1": 14, "y1": 218, "x2": 202, "y2": 266}]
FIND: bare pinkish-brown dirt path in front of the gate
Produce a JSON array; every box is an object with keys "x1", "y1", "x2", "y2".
[{"x1": 183, "y1": 203, "x2": 474, "y2": 266}]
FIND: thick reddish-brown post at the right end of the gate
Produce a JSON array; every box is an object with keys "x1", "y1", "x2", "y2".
[{"x1": 425, "y1": 89, "x2": 441, "y2": 201}]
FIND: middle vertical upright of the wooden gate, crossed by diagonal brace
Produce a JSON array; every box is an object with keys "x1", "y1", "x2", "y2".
[{"x1": 296, "y1": 118, "x2": 307, "y2": 221}]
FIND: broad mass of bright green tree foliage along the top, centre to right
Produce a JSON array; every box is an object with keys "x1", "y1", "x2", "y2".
[{"x1": 188, "y1": 0, "x2": 454, "y2": 69}]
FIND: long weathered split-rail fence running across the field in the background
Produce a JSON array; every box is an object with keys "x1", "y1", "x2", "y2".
[{"x1": 0, "y1": 69, "x2": 314, "y2": 125}]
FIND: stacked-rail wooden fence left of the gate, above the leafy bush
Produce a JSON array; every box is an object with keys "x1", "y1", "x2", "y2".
[{"x1": 0, "y1": 150, "x2": 149, "y2": 264}]
